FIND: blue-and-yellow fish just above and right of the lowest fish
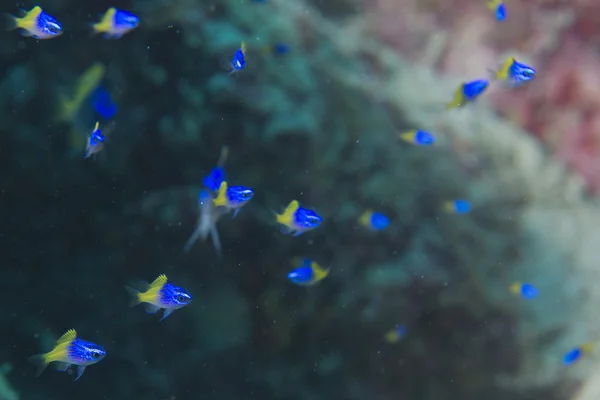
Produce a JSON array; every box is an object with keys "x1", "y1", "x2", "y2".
[{"x1": 125, "y1": 274, "x2": 192, "y2": 321}]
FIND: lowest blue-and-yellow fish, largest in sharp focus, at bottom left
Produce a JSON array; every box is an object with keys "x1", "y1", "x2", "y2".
[{"x1": 29, "y1": 329, "x2": 106, "y2": 380}]
